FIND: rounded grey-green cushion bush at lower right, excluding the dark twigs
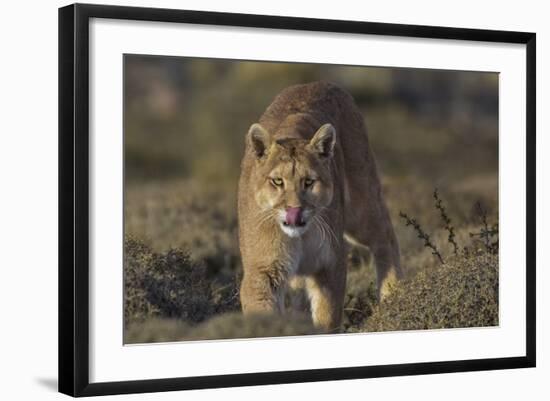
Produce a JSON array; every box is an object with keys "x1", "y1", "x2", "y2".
[{"x1": 364, "y1": 252, "x2": 498, "y2": 331}]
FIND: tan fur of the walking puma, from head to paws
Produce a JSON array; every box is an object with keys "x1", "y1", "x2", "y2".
[{"x1": 238, "y1": 82, "x2": 402, "y2": 332}]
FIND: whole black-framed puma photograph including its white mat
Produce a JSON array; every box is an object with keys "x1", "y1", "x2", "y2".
[{"x1": 59, "y1": 4, "x2": 536, "y2": 396}]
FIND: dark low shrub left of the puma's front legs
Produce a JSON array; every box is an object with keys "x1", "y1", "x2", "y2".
[{"x1": 124, "y1": 237, "x2": 239, "y2": 324}]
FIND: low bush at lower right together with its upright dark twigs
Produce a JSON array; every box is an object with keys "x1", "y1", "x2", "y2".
[{"x1": 364, "y1": 190, "x2": 499, "y2": 331}]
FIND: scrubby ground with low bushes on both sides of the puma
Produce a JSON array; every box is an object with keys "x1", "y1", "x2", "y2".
[{"x1": 125, "y1": 176, "x2": 498, "y2": 342}]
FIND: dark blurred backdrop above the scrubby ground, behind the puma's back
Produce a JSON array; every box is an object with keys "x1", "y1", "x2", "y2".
[{"x1": 125, "y1": 55, "x2": 498, "y2": 184}]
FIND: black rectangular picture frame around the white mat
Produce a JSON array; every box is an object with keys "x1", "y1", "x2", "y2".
[{"x1": 59, "y1": 4, "x2": 536, "y2": 396}]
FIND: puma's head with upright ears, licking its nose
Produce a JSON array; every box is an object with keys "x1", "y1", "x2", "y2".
[{"x1": 247, "y1": 120, "x2": 336, "y2": 237}]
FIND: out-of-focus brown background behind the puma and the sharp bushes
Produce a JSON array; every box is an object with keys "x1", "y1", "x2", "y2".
[{"x1": 124, "y1": 55, "x2": 498, "y2": 340}]
